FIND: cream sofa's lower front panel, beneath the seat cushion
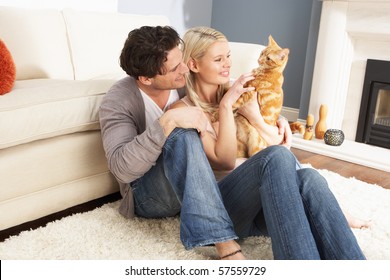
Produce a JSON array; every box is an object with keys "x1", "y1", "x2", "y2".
[{"x1": 0, "y1": 131, "x2": 119, "y2": 231}]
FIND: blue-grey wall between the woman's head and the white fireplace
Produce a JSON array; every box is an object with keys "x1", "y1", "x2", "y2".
[{"x1": 211, "y1": 0, "x2": 322, "y2": 119}]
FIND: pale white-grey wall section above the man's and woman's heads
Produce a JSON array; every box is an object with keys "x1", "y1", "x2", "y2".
[{"x1": 118, "y1": 0, "x2": 213, "y2": 35}]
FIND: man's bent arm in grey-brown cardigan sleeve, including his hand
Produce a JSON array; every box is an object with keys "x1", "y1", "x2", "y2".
[{"x1": 99, "y1": 80, "x2": 207, "y2": 183}]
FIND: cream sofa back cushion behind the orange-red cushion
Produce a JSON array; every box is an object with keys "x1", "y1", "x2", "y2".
[{"x1": 0, "y1": 6, "x2": 74, "y2": 80}]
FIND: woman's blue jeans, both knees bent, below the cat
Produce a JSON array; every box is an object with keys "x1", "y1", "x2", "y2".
[{"x1": 219, "y1": 146, "x2": 365, "y2": 260}]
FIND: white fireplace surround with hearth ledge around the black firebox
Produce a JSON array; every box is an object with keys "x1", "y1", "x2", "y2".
[{"x1": 293, "y1": 0, "x2": 390, "y2": 171}]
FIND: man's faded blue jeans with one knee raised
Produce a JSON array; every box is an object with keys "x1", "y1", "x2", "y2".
[{"x1": 131, "y1": 129, "x2": 238, "y2": 249}]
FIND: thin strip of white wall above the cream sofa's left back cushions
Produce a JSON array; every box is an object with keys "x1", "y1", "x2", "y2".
[{"x1": 0, "y1": 0, "x2": 118, "y2": 12}]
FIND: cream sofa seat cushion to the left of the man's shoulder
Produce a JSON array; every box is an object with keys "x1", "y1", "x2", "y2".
[{"x1": 0, "y1": 79, "x2": 115, "y2": 149}]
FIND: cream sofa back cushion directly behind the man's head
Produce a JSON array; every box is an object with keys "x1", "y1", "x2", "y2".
[{"x1": 63, "y1": 9, "x2": 169, "y2": 80}]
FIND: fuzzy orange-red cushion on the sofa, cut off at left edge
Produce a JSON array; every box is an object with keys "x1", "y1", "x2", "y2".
[{"x1": 0, "y1": 39, "x2": 16, "y2": 95}]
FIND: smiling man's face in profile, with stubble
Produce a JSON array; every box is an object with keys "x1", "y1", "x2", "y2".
[{"x1": 151, "y1": 47, "x2": 189, "y2": 90}]
